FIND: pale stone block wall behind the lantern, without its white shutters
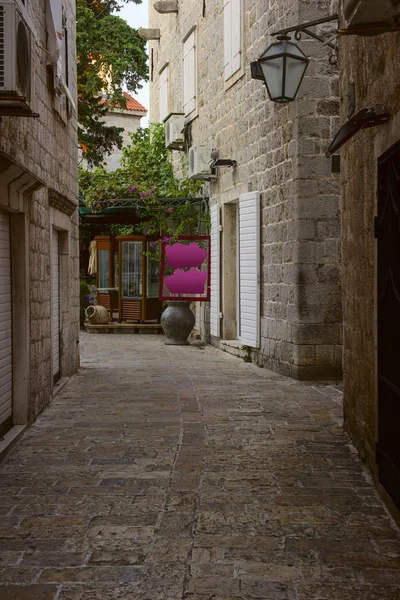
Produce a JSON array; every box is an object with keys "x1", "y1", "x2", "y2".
[{"x1": 150, "y1": 0, "x2": 342, "y2": 378}]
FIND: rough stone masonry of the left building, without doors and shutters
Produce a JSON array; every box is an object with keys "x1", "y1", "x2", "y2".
[{"x1": 0, "y1": 0, "x2": 79, "y2": 420}]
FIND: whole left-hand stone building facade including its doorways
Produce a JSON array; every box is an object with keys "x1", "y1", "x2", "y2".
[{"x1": 0, "y1": 0, "x2": 79, "y2": 440}]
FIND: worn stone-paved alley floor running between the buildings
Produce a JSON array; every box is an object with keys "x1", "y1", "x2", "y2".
[{"x1": 0, "y1": 334, "x2": 400, "y2": 600}]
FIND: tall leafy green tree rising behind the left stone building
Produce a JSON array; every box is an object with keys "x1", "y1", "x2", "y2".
[{"x1": 76, "y1": 0, "x2": 148, "y2": 166}]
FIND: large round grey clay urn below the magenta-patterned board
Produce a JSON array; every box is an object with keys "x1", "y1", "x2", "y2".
[{"x1": 160, "y1": 301, "x2": 195, "y2": 346}]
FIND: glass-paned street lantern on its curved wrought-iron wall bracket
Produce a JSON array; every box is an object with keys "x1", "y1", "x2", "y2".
[{"x1": 250, "y1": 15, "x2": 338, "y2": 103}]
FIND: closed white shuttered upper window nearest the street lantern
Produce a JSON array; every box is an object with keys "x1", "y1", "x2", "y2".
[{"x1": 224, "y1": 0, "x2": 243, "y2": 81}]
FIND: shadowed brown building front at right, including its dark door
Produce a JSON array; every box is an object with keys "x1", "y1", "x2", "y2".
[{"x1": 340, "y1": 2, "x2": 400, "y2": 509}]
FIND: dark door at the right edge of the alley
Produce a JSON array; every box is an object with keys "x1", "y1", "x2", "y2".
[{"x1": 376, "y1": 143, "x2": 400, "y2": 508}]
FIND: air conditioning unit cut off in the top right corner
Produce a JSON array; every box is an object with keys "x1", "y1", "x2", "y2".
[{"x1": 343, "y1": 0, "x2": 400, "y2": 27}]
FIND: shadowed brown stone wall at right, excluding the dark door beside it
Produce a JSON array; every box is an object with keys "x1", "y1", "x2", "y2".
[{"x1": 340, "y1": 22, "x2": 400, "y2": 476}]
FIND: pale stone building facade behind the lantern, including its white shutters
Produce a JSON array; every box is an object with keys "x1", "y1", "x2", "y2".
[{"x1": 149, "y1": 0, "x2": 342, "y2": 379}]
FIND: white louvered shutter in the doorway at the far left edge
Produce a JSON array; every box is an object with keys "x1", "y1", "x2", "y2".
[{"x1": 0, "y1": 211, "x2": 12, "y2": 425}]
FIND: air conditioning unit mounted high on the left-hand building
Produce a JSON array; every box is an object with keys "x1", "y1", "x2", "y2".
[{"x1": 0, "y1": 0, "x2": 32, "y2": 115}]
